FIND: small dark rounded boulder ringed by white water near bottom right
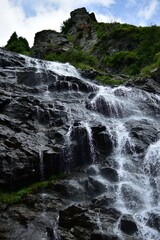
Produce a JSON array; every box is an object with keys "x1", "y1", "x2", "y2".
[{"x1": 120, "y1": 215, "x2": 138, "y2": 235}]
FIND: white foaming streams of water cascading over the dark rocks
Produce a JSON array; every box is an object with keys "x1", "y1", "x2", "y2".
[{"x1": 21, "y1": 58, "x2": 160, "y2": 240}]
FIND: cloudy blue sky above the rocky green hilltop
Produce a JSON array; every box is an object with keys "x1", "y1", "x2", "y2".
[{"x1": 0, "y1": 0, "x2": 160, "y2": 47}]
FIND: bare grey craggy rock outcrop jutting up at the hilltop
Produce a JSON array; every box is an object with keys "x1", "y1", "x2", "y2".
[{"x1": 32, "y1": 8, "x2": 97, "y2": 59}]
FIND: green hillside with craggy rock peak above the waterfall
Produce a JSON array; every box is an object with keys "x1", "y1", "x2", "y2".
[{"x1": 32, "y1": 8, "x2": 160, "y2": 79}]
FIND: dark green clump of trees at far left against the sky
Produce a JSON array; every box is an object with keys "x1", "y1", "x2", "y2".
[{"x1": 5, "y1": 32, "x2": 30, "y2": 55}]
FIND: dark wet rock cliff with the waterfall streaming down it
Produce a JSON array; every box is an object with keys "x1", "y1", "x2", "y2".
[{"x1": 0, "y1": 46, "x2": 160, "y2": 240}]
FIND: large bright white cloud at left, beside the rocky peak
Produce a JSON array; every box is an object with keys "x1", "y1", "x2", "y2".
[{"x1": 0, "y1": 0, "x2": 69, "y2": 46}]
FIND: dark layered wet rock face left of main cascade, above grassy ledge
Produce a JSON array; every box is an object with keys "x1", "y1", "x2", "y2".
[{"x1": 0, "y1": 47, "x2": 112, "y2": 189}]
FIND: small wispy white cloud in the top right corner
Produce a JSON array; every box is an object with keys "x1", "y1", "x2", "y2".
[{"x1": 138, "y1": 0, "x2": 159, "y2": 20}]
